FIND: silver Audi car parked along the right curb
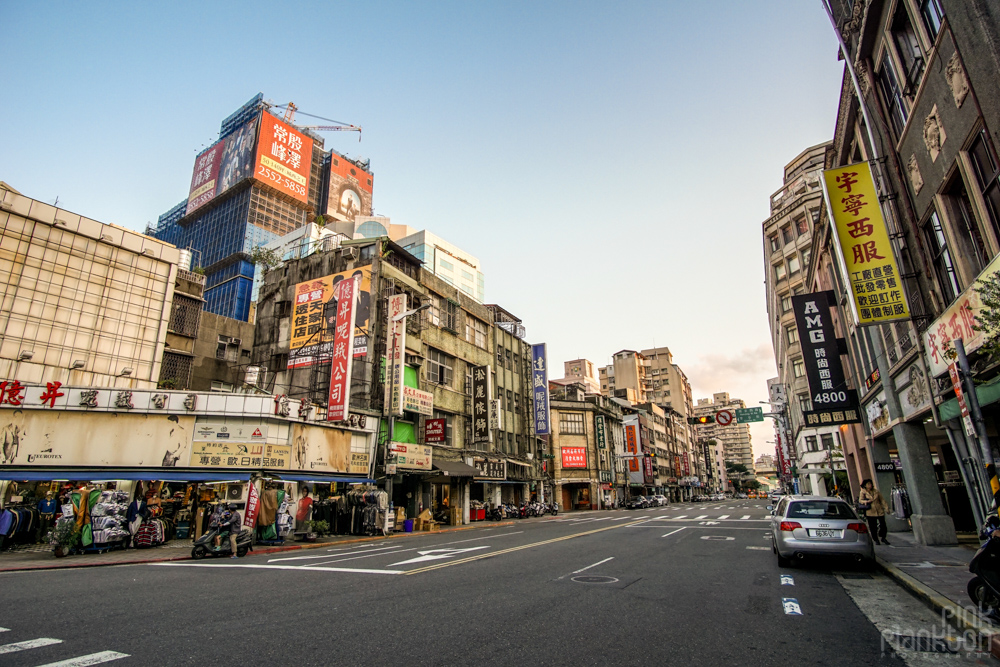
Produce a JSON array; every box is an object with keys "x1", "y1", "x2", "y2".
[{"x1": 768, "y1": 496, "x2": 875, "y2": 567}]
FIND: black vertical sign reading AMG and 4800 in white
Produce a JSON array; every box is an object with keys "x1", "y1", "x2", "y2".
[{"x1": 792, "y1": 292, "x2": 858, "y2": 424}]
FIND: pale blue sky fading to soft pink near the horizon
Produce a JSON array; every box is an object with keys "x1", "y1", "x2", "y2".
[{"x1": 0, "y1": 0, "x2": 843, "y2": 454}]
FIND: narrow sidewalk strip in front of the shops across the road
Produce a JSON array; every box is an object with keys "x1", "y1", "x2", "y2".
[{"x1": 0, "y1": 521, "x2": 514, "y2": 572}]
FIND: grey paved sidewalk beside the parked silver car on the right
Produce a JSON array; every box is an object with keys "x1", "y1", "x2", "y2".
[{"x1": 875, "y1": 533, "x2": 1000, "y2": 658}]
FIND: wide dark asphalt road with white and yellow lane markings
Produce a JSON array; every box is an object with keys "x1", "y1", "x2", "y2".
[{"x1": 0, "y1": 501, "x2": 986, "y2": 667}]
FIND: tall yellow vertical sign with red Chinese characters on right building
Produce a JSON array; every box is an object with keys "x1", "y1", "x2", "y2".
[{"x1": 823, "y1": 162, "x2": 910, "y2": 325}]
